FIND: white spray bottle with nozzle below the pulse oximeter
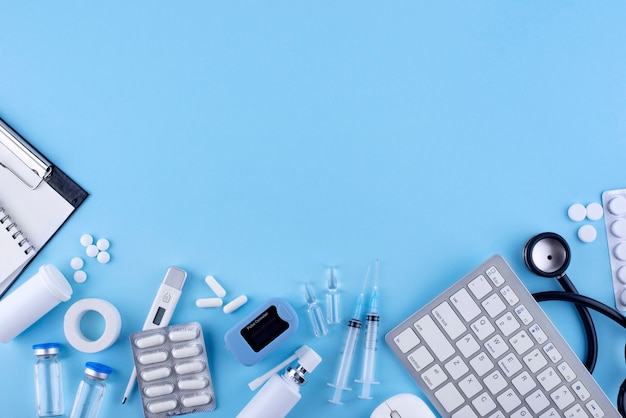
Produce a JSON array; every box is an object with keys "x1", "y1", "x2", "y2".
[{"x1": 237, "y1": 347, "x2": 322, "y2": 418}]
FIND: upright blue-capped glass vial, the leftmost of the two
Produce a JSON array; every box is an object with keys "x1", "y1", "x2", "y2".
[{"x1": 33, "y1": 343, "x2": 64, "y2": 417}]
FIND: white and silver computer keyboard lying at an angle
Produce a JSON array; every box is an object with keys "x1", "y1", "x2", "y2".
[{"x1": 385, "y1": 256, "x2": 620, "y2": 418}]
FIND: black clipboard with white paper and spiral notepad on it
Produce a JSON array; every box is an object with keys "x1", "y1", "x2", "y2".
[{"x1": 0, "y1": 118, "x2": 89, "y2": 297}]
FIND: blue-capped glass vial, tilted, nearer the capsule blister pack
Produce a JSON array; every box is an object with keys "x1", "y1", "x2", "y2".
[{"x1": 70, "y1": 362, "x2": 112, "y2": 418}]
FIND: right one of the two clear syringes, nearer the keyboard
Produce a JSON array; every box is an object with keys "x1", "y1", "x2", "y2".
[{"x1": 355, "y1": 259, "x2": 380, "y2": 399}]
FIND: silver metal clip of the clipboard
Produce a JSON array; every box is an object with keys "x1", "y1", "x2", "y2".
[{"x1": 0, "y1": 119, "x2": 52, "y2": 190}]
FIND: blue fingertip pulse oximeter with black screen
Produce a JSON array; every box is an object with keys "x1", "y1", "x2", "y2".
[{"x1": 224, "y1": 298, "x2": 298, "y2": 366}]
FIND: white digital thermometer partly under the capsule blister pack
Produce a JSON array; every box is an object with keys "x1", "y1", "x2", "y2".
[{"x1": 122, "y1": 266, "x2": 187, "y2": 403}]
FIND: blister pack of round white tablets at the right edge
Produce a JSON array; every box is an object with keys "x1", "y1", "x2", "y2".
[{"x1": 602, "y1": 189, "x2": 626, "y2": 311}]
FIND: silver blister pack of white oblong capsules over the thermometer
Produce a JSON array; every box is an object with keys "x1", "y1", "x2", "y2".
[{"x1": 130, "y1": 322, "x2": 215, "y2": 418}]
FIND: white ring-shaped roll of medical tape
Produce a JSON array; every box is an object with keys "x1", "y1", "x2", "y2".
[{"x1": 63, "y1": 298, "x2": 122, "y2": 353}]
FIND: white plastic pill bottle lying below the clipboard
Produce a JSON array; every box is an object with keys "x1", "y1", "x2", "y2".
[{"x1": 0, "y1": 264, "x2": 72, "y2": 343}]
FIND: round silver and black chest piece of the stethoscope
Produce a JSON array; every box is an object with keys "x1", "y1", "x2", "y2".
[{"x1": 522, "y1": 232, "x2": 571, "y2": 277}]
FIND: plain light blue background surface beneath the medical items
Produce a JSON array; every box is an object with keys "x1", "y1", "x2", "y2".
[{"x1": 0, "y1": 1, "x2": 626, "y2": 418}]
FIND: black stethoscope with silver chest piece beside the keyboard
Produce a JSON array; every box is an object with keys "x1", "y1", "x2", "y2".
[{"x1": 522, "y1": 232, "x2": 626, "y2": 417}]
